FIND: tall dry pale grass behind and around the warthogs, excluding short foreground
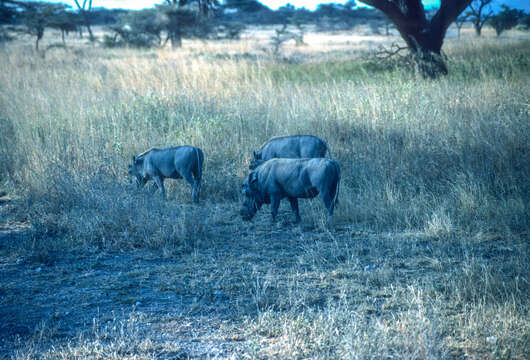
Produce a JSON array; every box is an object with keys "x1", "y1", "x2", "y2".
[{"x1": 0, "y1": 35, "x2": 530, "y2": 248}]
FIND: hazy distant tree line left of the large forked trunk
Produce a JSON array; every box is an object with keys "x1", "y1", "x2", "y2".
[{"x1": 0, "y1": 0, "x2": 396, "y2": 49}]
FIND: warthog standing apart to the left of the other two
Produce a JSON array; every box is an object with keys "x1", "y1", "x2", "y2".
[{"x1": 129, "y1": 146, "x2": 204, "y2": 202}]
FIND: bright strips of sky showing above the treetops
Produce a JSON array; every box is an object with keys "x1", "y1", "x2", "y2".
[{"x1": 46, "y1": 0, "x2": 530, "y2": 12}]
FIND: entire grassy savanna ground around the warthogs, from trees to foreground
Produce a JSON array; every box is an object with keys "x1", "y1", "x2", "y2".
[{"x1": 0, "y1": 29, "x2": 530, "y2": 359}]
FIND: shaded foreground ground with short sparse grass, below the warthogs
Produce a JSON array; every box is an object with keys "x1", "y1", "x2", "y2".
[{"x1": 0, "y1": 194, "x2": 528, "y2": 359}]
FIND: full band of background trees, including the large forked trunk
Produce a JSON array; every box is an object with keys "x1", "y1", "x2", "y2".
[{"x1": 0, "y1": 0, "x2": 529, "y2": 77}]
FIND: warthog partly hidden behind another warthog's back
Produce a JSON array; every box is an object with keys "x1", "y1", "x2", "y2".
[{"x1": 248, "y1": 135, "x2": 331, "y2": 170}]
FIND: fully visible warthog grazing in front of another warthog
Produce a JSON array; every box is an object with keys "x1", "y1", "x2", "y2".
[{"x1": 241, "y1": 158, "x2": 340, "y2": 223}]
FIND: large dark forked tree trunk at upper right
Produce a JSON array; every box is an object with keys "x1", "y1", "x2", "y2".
[{"x1": 360, "y1": 0, "x2": 472, "y2": 78}]
